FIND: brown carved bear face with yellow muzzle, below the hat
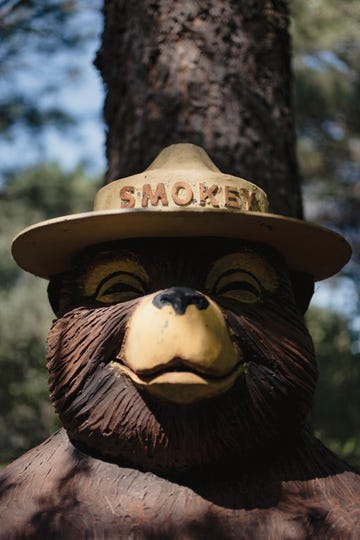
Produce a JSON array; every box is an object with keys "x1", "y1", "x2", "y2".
[{"x1": 47, "y1": 238, "x2": 317, "y2": 474}]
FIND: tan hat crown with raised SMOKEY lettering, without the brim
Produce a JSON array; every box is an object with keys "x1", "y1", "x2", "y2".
[{"x1": 94, "y1": 143, "x2": 269, "y2": 212}]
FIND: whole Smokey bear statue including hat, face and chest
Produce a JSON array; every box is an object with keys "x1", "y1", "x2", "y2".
[{"x1": 0, "y1": 144, "x2": 360, "y2": 540}]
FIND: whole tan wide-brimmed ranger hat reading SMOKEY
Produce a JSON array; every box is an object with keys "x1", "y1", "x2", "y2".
[{"x1": 12, "y1": 144, "x2": 351, "y2": 281}]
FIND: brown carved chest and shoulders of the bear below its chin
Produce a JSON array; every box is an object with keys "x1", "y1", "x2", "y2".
[{"x1": 0, "y1": 462, "x2": 356, "y2": 540}]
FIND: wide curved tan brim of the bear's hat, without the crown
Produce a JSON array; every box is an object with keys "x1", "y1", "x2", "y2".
[{"x1": 12, "y1": 209, "x2": 351, "y2": 281}]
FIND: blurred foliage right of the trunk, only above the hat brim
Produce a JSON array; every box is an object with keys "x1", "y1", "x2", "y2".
[{"x1": 290, "y1": 0, "x2": 360, "y2": 274}]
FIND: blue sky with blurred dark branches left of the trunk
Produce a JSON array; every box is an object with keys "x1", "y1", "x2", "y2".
[{"x1": 0, "y1": 0, "x2": 104, "y2": 180}]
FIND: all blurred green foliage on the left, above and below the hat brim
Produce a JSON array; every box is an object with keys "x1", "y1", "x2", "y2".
[{"x1": 0, "y1": 164, "x2": 96, "y2": 463}]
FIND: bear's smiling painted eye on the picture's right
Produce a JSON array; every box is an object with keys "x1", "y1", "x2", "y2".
[{"x1": 213, "y1": 270, "x2": 262, "y2": 304}]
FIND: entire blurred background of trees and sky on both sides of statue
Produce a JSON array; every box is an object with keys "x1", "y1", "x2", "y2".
[{"x1": 0, "y1": 0, "x2": 360, "y2": 467}]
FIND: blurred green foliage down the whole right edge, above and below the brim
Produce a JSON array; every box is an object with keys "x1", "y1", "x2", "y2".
[{"x1": 290, "y1": 0, "x2": 360, "y2": 468}]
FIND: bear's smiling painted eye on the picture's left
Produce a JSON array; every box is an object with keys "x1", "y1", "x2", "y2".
[{"x1": 94, "y1": 270, "x2": 147, "y2": 304}]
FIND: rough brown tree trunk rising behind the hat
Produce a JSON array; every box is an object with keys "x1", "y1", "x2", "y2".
[{"x1": 97, "y1": 0, "x2": 302, "y2": 217}]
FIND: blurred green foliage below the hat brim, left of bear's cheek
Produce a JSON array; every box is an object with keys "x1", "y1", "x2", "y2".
[{"x1": 0, "y1": 276, "x2": 55, "y2": 463}]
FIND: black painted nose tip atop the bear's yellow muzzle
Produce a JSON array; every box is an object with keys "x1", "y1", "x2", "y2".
[{"x1": 153, "y1": 287, "x2": 209, "y2": 315}]
